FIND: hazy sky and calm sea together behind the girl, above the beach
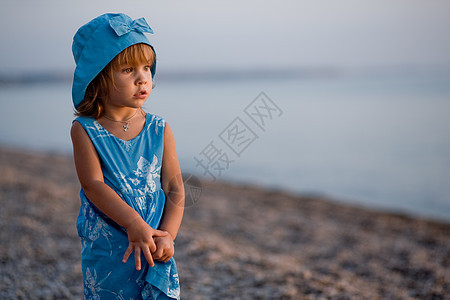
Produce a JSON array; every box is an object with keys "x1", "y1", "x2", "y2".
[{"x1": 0, "y1": 0, "x2": 450, "y2": 221}]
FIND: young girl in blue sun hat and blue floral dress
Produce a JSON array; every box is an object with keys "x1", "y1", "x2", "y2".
[{"x1": 71, "y1": 14, "x2": 184, "y2": 299}]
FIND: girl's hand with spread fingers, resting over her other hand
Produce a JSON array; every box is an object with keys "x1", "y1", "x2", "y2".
[{"x1": 122, "y1": 218, "x2": 169, "y2": 270}]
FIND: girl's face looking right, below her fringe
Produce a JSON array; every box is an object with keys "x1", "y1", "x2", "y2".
[{"x1": 105, "y1": 63, "x2": 152, "y2": 108}]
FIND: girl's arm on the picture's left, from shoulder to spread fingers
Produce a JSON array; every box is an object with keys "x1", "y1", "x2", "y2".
[{"x1": 70, "y1": 122, "x2": 167, "y2": 270}]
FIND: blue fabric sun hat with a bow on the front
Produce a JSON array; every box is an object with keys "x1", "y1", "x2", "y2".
[{"x1": 72, "y1": 13, "x2": 156, "y2": 108}]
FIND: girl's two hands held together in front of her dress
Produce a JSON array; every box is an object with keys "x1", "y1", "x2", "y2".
[{"x1": 122, "y1": 218, "x2": 175, "y2": 270}]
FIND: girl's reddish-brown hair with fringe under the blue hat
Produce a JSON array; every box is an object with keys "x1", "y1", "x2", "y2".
[{"x1": 75, "y1": 44, "x2": 156, "y2": 119}]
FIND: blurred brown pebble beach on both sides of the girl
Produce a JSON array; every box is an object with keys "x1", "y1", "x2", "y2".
[{"x1": 0, "y1": 147, "x2": 450, "y2": 300}]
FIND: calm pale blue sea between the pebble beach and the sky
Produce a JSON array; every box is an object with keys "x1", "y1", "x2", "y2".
[{"x1": 0, "y1": 72, "x2": 450, "y2": 221}]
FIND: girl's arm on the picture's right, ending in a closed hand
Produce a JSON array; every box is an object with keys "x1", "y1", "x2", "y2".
[{"x1": 153, "y1": 123, "x2": 185, "y2": 262}]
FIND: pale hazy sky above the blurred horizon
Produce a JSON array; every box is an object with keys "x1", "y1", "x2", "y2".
[{"x1": 0, "y1": 0, "x2": 450, "y2": 73}]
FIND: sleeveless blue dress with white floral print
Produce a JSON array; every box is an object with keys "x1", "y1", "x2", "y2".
[{"x1": 76, "y1": 114, "x2": 180, "y2": 299}]
